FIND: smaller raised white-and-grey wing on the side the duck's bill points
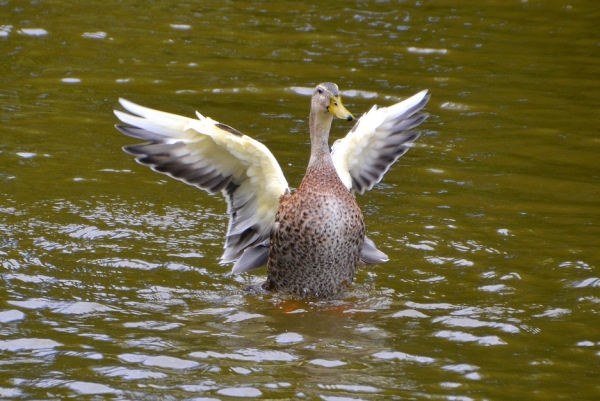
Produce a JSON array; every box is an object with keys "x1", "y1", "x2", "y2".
[{"x1": 331, "y1": 90, "x2": 429, "y2": 194}]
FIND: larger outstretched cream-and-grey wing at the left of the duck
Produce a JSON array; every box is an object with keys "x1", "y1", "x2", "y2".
[{"x1": 115, "y1": 99, "x2": 289, "y2": 273}]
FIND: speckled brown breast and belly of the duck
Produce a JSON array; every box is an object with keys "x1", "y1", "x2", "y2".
[{"x1": 265, "y1": 163, "x2": 365, "y2": 298}]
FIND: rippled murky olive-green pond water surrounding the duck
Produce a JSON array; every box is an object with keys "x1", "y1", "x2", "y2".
[{"x1": 0, "y1": 0, "x2": 600, "y2": 401}]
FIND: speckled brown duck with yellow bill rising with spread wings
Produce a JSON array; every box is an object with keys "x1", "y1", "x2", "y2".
[{"x1": 114, "y1": 82, "x2": 430, "y2": 299}]
